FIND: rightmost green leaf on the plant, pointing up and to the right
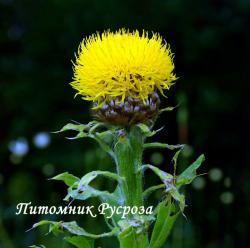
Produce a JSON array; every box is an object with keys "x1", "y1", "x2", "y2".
[{"x1": 176, "y1": 154, "x2": 205, "y2": 187}]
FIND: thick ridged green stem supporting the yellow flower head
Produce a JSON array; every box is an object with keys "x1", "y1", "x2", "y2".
[{"x1": 114, "y1": 126, "x2": 148, "y2": 248}]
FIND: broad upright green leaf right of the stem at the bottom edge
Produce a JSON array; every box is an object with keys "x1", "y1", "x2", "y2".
[{"x1": 149, "y1": 200, "x2": 179, "y2": 248}]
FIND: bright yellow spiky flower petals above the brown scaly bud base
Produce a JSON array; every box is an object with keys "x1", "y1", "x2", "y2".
[{"x1": 71, "y1": 29, "x2": 176, "y2": 107}]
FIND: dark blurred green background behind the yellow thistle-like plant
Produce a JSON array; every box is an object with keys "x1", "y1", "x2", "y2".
[{"x1": 0, "y1": 0, "x2": 250, "y2": 248}]
